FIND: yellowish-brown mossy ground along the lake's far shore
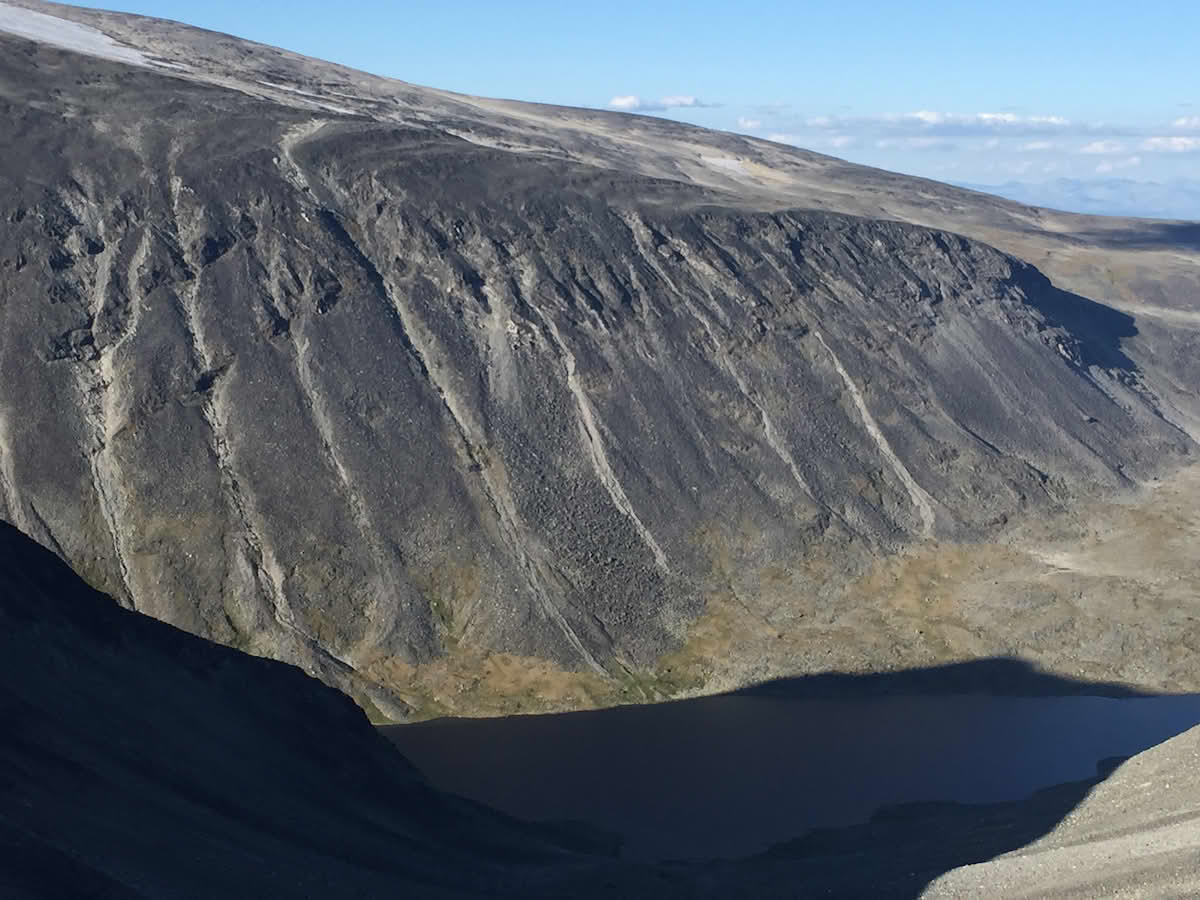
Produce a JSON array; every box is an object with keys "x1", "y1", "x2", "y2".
[{"x1": 365, "y1": 467, "x2": 1200, "y2": 719}]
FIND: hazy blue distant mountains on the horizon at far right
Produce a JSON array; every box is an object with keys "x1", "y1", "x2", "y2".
[{"x1": 954, "y1": 178, "x2": 1200, "y2": 220}]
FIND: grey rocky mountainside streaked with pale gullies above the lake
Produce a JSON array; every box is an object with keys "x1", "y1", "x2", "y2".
[{"x1": 0, "y1": 2, "x2": 1200, "y2": 718}]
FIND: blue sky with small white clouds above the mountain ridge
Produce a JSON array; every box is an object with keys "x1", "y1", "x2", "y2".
[{"x1": 105, "y1": 0, "x2": 1200, "y2": 184}]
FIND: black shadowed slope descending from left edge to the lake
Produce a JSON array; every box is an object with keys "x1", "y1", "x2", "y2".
[{"x1": 0, "y1": 523, "x2": 604, "y2": 900}]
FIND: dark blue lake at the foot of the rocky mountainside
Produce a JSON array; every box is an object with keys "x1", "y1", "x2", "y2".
[{"x1": 385, "y1": 695, "x2": 1200, "y2": 859}]
